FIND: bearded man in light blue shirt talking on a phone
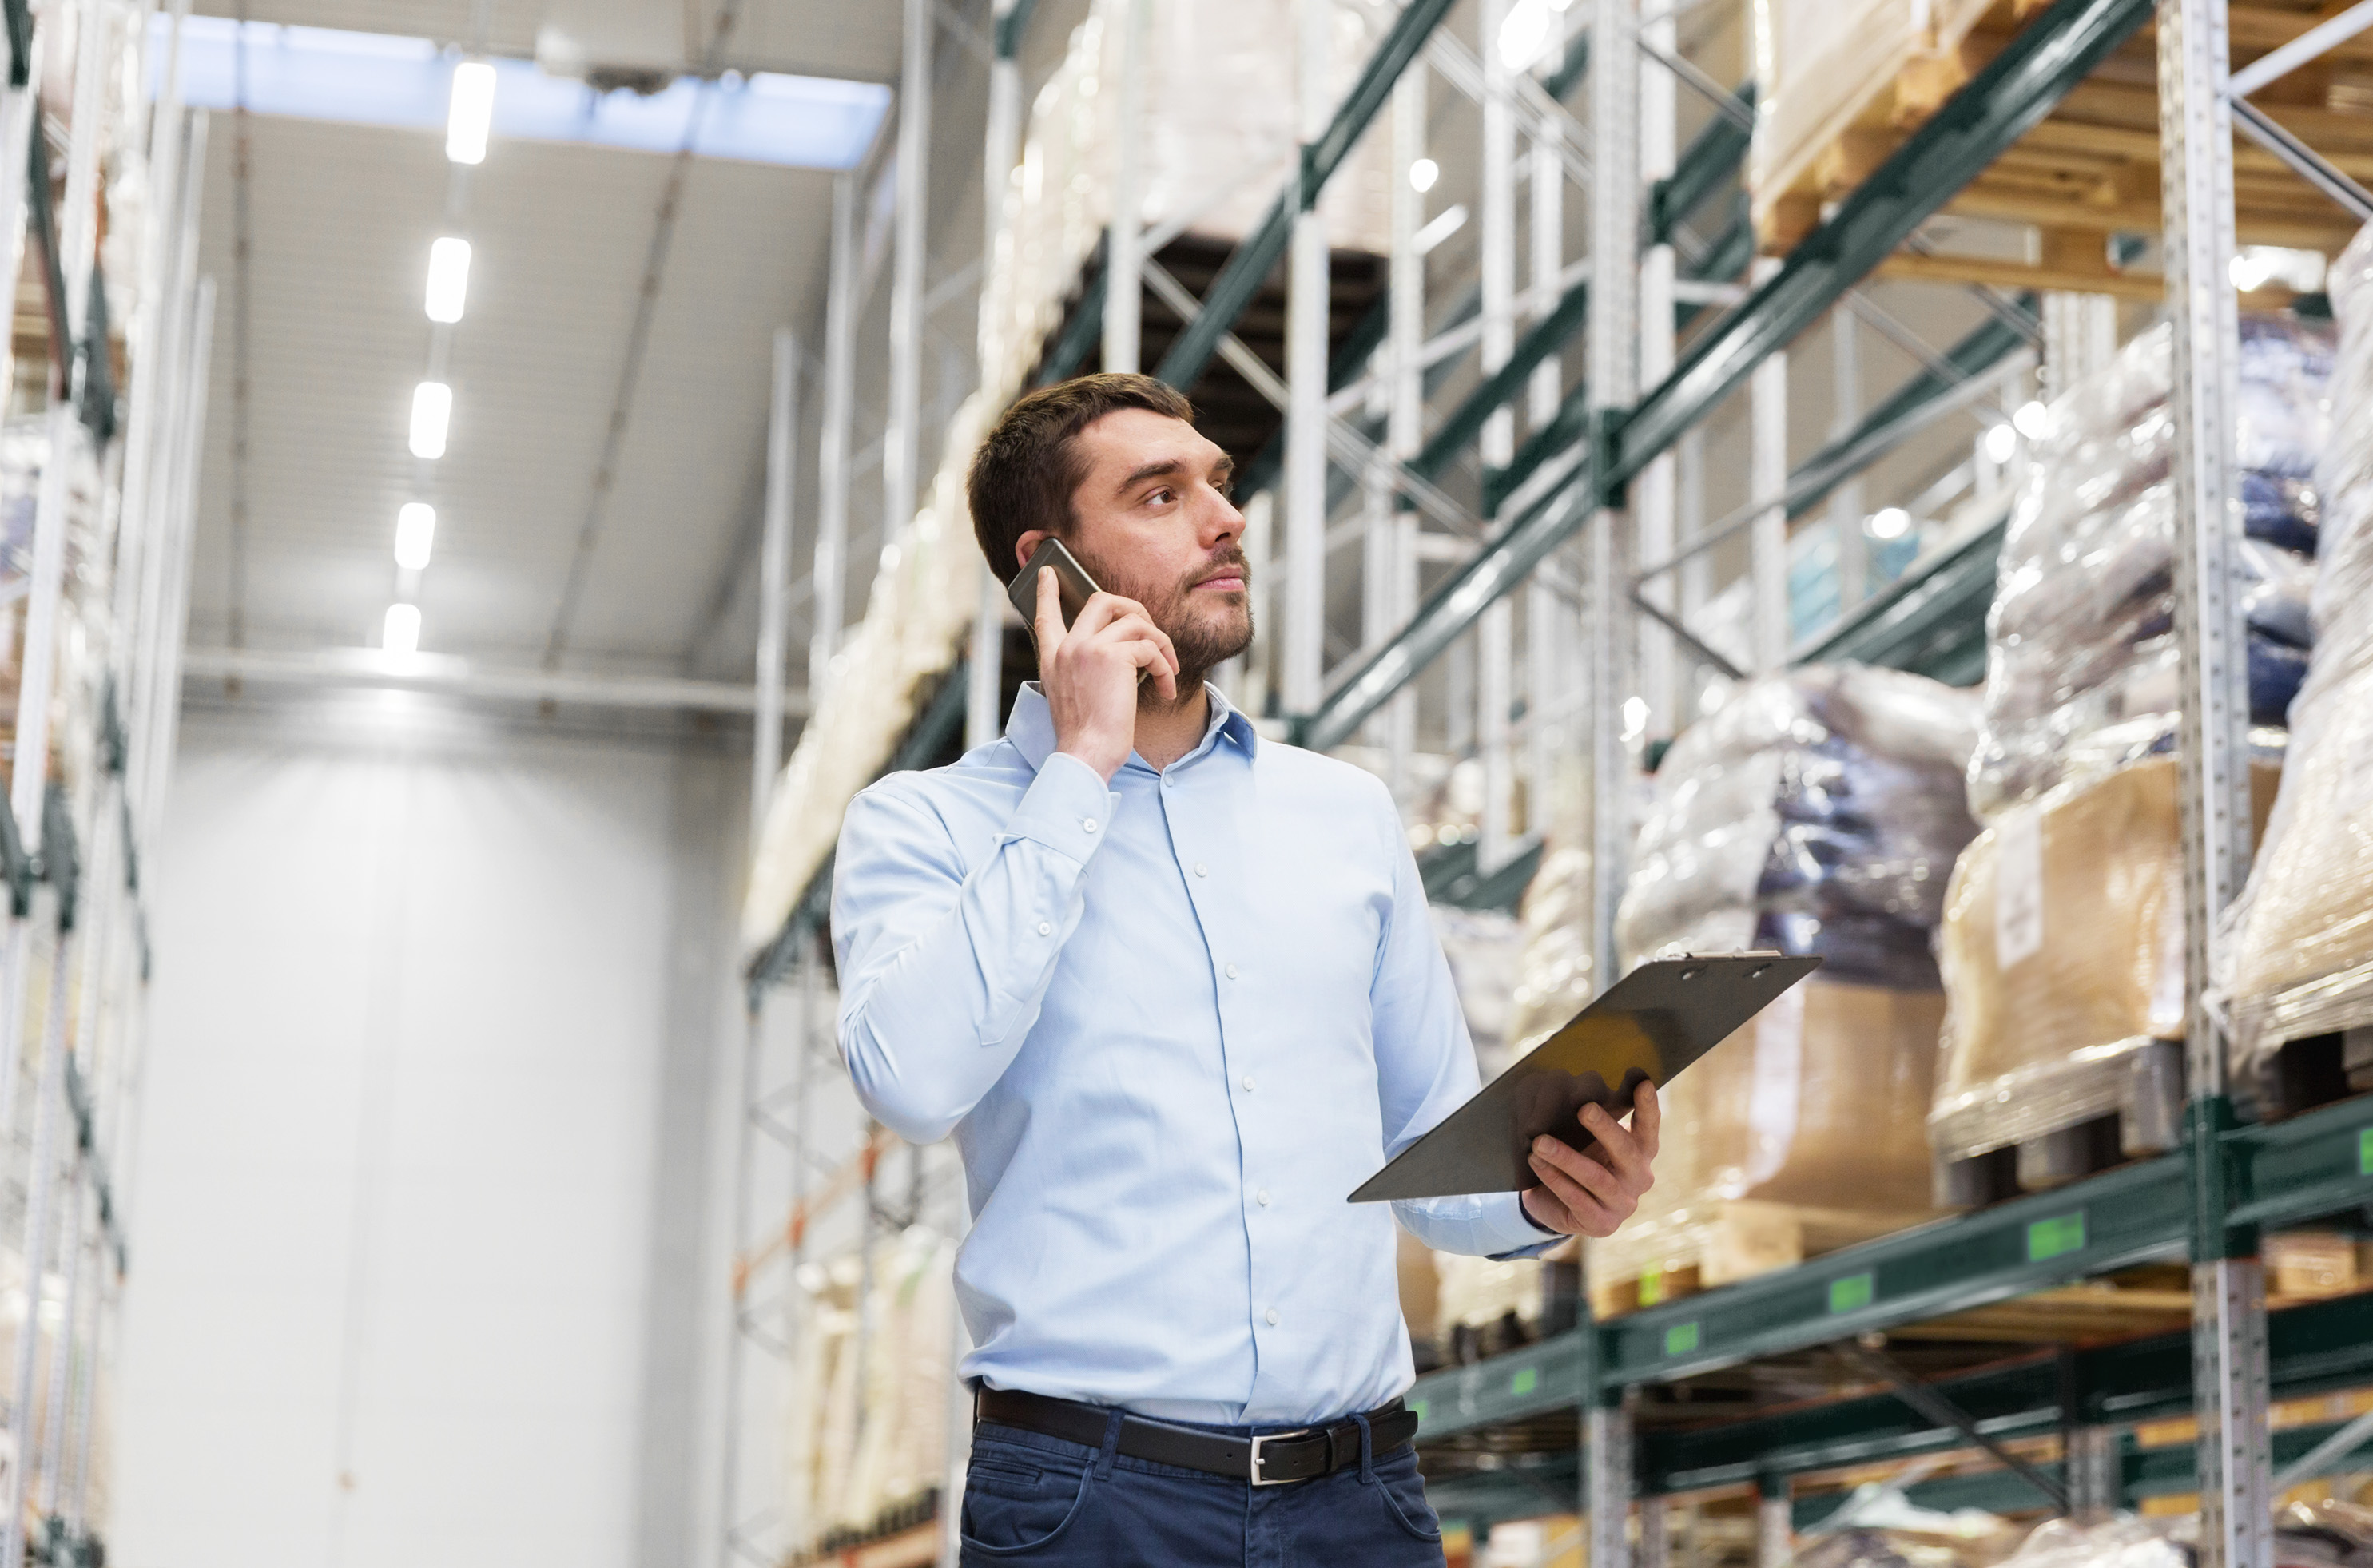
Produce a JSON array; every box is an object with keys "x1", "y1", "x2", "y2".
[{"x1": 833, "y1": 375, "x2": 1659, "y2": 1568}]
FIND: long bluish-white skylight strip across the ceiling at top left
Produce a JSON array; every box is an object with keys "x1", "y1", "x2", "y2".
[{"x1": 149, "y1": 14, "x2": 890, "y2": 169}]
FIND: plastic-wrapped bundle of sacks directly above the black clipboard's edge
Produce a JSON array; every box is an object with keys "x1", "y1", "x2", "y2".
[{"x1": 1616, "y1": 665, "x2": 1977, "y2": 989}]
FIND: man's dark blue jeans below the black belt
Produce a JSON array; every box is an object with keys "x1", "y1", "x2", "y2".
[{"x1": 964, "y1": 1416, "x2": 1443, "y2": 1568}]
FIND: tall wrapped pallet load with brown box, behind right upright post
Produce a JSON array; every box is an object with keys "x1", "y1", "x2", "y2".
[{"x1": 1930, "y1": 316, "x2": 2333, "y2": 1208}]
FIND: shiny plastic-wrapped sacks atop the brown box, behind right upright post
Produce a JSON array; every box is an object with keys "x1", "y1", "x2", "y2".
[{"x1": 1970, "y1": 316, "x2": 2333, "y2": 819}]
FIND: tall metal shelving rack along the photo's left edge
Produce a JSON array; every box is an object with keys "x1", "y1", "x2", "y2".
[{"x1": 0, "y1": 0, "x2": 213, "y2": 1568}]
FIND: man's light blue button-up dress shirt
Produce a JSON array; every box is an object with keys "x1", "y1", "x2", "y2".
[{"x1": 833, "y1": 688, "x2": 1554, "y2": 1423}]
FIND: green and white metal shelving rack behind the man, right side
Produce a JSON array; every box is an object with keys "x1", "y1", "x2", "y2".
[{"x1": 735, "y1": 0, "x2": 2373, "y2": 1568}]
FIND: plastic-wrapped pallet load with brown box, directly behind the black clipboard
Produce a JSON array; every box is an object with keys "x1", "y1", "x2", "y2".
[{"x1": 1588, "y1": 665, "x2": 1977, "y2": 1316}]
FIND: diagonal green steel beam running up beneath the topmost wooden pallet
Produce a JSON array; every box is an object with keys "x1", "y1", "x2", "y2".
[{"x1": 1600, "y1": 0, "x2": 2150, "y2": 491}]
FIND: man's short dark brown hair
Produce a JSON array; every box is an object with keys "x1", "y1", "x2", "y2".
[{"x1": 964, "y1": 372, "x2": 1194, "y2": 582}]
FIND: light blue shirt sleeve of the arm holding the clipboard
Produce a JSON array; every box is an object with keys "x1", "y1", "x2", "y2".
[{"x1": 1369, "y1": 783, "x2": 1564, "y2": 1257}]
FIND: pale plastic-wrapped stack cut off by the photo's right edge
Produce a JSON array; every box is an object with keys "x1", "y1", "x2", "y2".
[{"x1": 2219, "y1": 228, "x2": 2373, "y2": 1105}]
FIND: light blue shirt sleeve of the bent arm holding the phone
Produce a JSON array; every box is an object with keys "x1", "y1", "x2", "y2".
[{"x1": 833, "y1": 752, "x2": 1120, "y2": 1143}]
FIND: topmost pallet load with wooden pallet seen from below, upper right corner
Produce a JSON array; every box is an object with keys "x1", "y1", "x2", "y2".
[{"x1": 1747, "y1": 0, "x2": 2373, "y2": 301}]
